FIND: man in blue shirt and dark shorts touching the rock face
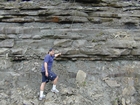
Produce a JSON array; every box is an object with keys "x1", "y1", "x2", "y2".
[{"x1": 39, "y1": 48, "x2": 61, "y2": 100}]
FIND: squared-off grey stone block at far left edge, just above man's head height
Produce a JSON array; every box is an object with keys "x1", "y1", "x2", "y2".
[{"x1": 0, "y1": 39, "x2": 14, "y2": 48}]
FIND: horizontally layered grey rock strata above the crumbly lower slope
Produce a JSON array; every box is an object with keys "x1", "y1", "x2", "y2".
[{"x1": 0, "y1": 0, "x2": 140, "y2": 60}]
